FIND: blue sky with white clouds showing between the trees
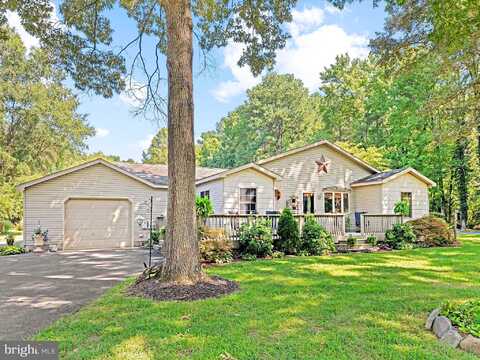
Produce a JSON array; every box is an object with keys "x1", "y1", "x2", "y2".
[{"x1": 8, "y1": 0, "x2": 385, "y2": 161}]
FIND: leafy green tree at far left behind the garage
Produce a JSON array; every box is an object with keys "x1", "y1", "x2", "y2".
[{"x1": 0, "y1": 29, "x2": 94, "y2": 221}]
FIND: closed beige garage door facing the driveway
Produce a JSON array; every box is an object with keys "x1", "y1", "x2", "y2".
[{"x1": 63, "y1": 199, "x2": 132, "y2": 250}]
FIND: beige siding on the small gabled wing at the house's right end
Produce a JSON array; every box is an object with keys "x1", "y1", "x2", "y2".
[{"x1": 381, "y1": 173, "x2": 429, "y2": 219}]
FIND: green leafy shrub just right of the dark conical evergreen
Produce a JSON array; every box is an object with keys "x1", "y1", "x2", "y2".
[{"x1": 302, "y1": 216, "x2": 335, "y2": 255}]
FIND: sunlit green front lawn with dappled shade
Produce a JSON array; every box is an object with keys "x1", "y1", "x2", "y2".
[{"x1": 36, "y1": 236, "x2": 480, "y2": 360}]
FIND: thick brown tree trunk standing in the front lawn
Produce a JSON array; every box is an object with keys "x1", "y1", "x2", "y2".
[{"x1": 162, "y1": 0, "x2": 201, "y2": 283}]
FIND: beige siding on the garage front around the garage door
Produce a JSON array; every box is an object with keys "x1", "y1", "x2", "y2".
[{"x1": 24, "y1": 164, "x2": 167, "y2": 248}]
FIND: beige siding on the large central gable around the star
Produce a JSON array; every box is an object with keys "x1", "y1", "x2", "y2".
[{"x1": 262, "y1": 145, "x2": 372, "y2": 213}]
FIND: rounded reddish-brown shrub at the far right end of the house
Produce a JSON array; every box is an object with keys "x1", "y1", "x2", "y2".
[{"x1": 407, "y1": 216, "x2": 454, "y2": 247}]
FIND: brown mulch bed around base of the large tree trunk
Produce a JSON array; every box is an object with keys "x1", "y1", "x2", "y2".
[{"x1": 126, "y1": 276, "x2": 239, "y2": 301}]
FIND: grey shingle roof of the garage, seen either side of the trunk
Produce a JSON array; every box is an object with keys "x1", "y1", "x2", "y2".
[{"x1": 115, "y1": 162, "x2": 225, "y2": 185}]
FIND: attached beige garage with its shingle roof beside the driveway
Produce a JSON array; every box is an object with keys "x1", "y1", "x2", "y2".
[{"x1": 18, "y1": 159, "x2": 222, "y2": 250}]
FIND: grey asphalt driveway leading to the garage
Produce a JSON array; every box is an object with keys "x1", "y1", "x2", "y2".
[{"x1": 0, "y1": 249, "x2": 158, "y2": 340}]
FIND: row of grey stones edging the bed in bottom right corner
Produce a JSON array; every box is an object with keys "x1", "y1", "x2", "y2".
[{"x1": 425, "y1": 308, "x2": 480, "y2": 356}]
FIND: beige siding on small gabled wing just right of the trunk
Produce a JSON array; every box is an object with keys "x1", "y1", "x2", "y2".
[{"x1": 223, "y1": 169, "x2": 274, "y2": 214}]
